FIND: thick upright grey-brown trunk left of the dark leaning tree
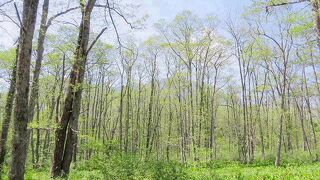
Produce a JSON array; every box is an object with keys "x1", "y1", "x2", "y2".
[{"x1": 9, "y1": 0, "x2": 39, "y2": 179}]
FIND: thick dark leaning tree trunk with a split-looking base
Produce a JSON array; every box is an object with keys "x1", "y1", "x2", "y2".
[{"x1": 52, "y1": 0, "x2": 96, "y2": 177}]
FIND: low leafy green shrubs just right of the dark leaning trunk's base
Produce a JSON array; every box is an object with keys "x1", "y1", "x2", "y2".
[{"x1": 70, "y1": 154, "x2": 188, "y2": 180}]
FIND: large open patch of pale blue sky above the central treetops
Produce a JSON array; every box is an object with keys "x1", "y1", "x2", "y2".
[{"x1": 132, "y1": 0, "x2": 252, "y2": 40}]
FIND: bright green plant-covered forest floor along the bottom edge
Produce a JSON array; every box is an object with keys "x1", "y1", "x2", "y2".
[{"x1": 5, "y1": 160, "x2": 320, "y2": 180}]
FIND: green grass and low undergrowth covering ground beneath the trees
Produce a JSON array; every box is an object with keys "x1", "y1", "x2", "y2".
[{"x1": 3, "y1": 152, "x2": 320, "y2": 180}]
